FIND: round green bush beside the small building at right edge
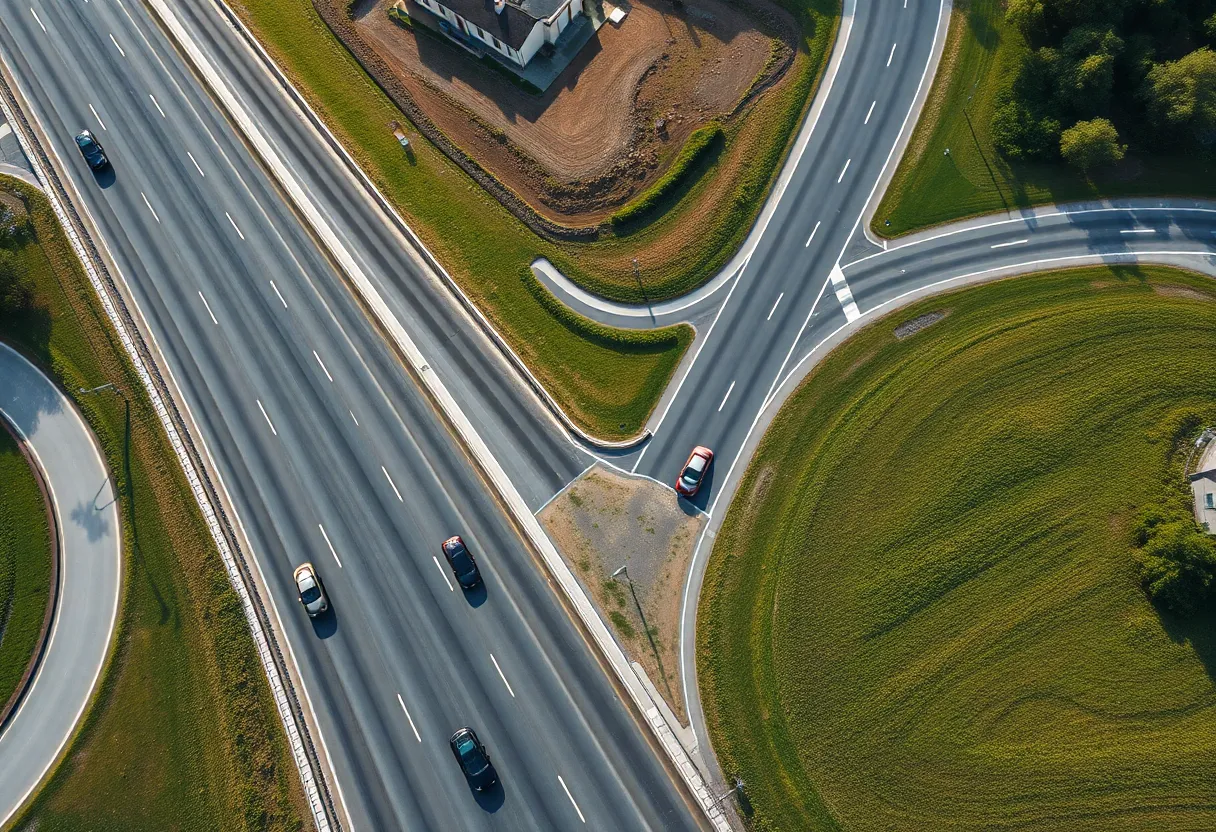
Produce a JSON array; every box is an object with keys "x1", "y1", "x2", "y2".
[{"x1": 1136, "y1": 505, "x2": 1216, "y2": 614}]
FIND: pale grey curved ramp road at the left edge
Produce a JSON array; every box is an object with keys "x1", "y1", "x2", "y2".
[{"x1": 0, "y1": 344, "x2": 123, "y2": 825}]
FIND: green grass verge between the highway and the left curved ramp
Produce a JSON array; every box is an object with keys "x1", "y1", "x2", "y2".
[{"x1": 0, "y1": 178, "x2": 306, "y2": 832}]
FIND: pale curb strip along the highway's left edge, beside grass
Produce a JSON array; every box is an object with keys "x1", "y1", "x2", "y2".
[{"x1": 0, "y1": 62, "x2": 337, "y2": 832}]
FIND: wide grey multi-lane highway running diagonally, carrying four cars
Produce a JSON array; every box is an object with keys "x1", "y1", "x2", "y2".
[{"x1": 0, "y1": 0, "x2": 699, "y2": 830}]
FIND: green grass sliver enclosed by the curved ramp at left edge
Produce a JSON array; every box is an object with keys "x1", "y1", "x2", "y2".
[{"x1": 0, "y1": 427, "x2": 52, "y2": 710}]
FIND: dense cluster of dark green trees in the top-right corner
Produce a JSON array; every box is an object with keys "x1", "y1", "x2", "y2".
[{"x1": 992, "y1": 0, "x2": 1216, "y2": 170}]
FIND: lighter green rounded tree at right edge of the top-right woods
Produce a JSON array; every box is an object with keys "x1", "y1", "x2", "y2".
[{"x1": 1144, "y1": 46, "x2": 1216, "y2": 147}]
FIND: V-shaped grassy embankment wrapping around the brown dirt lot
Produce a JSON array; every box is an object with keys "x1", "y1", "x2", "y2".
[{"x1": 226, "y1": 0, "x2": 839, "y2": 438}]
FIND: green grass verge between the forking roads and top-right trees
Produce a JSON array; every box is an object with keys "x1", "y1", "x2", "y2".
[{"x1": 873, "y1": 0, "x2": 1216, "y2": 236}]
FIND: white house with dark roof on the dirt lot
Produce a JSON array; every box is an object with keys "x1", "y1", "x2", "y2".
[{"x1": 413, "y1": 0, "x2": 582, "y2": 68}]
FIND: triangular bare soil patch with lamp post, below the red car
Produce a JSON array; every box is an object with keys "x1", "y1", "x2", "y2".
[{"x1": 539, "y1": 466, "x2": 704, "y2": 716}]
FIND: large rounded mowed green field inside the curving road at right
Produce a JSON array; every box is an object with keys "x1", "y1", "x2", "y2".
[{"x1": 697, "y1": 268, "x2": 1216, "y2": 832}]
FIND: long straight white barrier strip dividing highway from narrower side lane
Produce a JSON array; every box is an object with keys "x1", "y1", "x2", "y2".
[{"x1": 147, "y1": 0, "x2": 731, "y2": 832}]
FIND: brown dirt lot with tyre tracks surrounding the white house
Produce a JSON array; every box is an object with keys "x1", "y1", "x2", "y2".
[{"x1": 355, "y1": 0, "x2": 798, "y2": 225}]
